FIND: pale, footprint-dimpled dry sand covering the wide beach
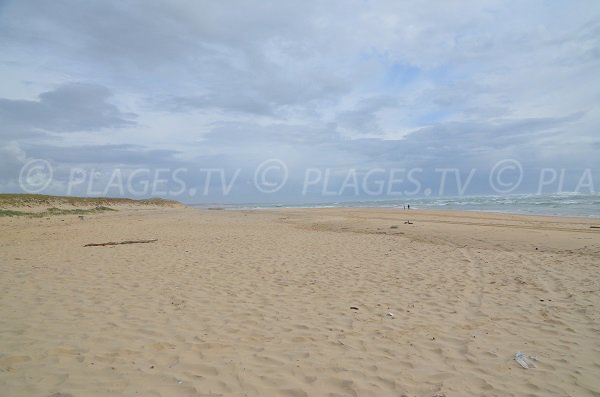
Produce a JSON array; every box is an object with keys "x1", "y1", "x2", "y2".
[{"x1": 0, "y1": 208, "x2": 600, "y2": 397}]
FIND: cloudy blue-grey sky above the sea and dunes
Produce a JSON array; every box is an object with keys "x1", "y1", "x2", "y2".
[{"x1": 0, "y1": 0, "x2": 600, "y2": 203}]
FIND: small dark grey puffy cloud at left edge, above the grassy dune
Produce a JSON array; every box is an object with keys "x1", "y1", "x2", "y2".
[{"x1": 0, "y1": 84, "x2": 136, "y2": 138}]
